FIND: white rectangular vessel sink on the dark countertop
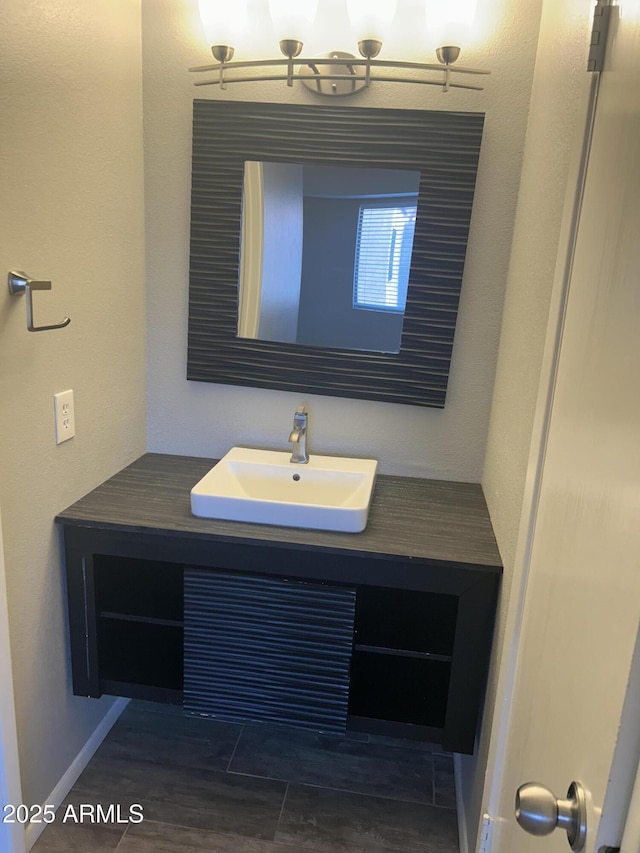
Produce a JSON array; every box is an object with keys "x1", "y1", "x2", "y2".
[{"x1": 191, "y1": 447, "x2": 378, "y2": 533}]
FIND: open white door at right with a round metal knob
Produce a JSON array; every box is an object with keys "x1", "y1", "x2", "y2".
[{"x1": 480, "y1": 0, "x2": 640, "y2": 853}]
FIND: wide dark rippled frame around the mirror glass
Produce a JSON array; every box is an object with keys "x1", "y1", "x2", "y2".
[{"x1": 187, "y1": 100, "x2": 484, "y2": 408}]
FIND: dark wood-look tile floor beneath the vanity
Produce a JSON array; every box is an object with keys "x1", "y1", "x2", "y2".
[{"x1": 32, "y1": 702, "x2": 459, "y2": 853}]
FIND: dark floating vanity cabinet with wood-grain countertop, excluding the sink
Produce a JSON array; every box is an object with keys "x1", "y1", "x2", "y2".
[{"x1": 56, "y1": 454, "x2": 502, "y2": 753}]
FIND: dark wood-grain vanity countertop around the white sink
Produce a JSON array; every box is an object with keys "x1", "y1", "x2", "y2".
[{"x1": 56, "y1": 453, "x2": 502, "y2": 572}]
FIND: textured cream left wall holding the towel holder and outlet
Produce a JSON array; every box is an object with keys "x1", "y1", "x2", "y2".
[{"x1": 0, "y1": 0, "x2": 145, "y2": 803}]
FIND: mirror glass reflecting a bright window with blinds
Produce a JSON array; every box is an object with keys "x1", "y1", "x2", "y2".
[{"x1": 237, "y1": 160, "x2": 420, "y2": 353}]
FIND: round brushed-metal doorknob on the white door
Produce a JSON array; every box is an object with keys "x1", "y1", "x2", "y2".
[{"x1": 516, "y1": 782, "x2": 587, "y2": 851}]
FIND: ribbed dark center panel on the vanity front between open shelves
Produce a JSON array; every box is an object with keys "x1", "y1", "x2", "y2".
[{"x1": 184, "y1": 568, "x2": 355, "y2": 731}]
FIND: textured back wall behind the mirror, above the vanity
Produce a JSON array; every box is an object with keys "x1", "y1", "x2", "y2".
[{"x1": 142, "y1": 0, "x2": 540, "y2": 481}]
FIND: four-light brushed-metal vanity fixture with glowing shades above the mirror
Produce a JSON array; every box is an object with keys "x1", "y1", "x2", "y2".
[{"x1": 189, "y1": 0, "x2": 490, "y2": 95}]
